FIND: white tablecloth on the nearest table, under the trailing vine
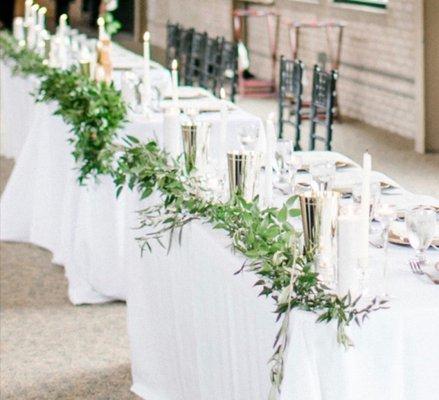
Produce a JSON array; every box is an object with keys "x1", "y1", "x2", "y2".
[{"x1": 121, "y1": 164, "x2": 439, "y2": 400}]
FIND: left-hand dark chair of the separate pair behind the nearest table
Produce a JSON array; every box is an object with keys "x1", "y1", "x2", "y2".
[{"x1": 278, "y1": 56, "x2": 305, "y2": 150}]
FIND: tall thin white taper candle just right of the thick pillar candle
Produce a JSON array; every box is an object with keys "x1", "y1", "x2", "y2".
[{"x1": 360, "y1": 152, "x2": 372, "y2": 268}]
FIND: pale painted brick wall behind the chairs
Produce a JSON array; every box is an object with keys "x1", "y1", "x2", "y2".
[{"x1": 148, "y1": 0, "x2": 417, "y2": 138}]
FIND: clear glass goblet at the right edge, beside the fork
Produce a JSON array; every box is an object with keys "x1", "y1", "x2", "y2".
[{"x1": 405, "y1": 206, "x2": 436, "y2": 264}]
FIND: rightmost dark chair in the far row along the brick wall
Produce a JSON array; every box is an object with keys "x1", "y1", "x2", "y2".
[{"x1": 214, "y1": 38, "x2": 238, "y2": 102}]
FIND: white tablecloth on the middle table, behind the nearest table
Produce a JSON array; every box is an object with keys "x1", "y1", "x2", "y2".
[{"x1": 0, "y1": 74, "x2": 259, "y2": 304}]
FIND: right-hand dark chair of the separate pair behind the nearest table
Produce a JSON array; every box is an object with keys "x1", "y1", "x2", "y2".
[{"x1": 309, "y1": 65, "x2": 338, "y2": 150}]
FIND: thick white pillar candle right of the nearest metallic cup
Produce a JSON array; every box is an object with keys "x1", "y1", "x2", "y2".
[{"x1": 337, "y1": 204, "x2": 362, "y2": 296}]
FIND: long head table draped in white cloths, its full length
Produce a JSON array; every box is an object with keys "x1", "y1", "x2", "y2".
[{"x1": 0, "y1": 39, "x2": 439, "y2": 400}]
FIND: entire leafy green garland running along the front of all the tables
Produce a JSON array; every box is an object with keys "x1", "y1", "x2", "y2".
[{"x1": 0, "y1": 33, "x2": 386, "y2": 399}]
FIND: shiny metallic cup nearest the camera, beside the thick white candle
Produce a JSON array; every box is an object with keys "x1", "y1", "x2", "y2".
[{"x1": 299, "y1": 191, "x2": 340, "y2": 286}]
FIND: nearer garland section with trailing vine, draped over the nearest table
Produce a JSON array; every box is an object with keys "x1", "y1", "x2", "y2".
[{"x1": 114, "y1": 137, "x2": 386, "y2": 399}]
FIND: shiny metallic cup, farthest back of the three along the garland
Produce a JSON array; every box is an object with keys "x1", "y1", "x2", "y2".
[{"x1": 181, "y1": 121, "x2": 211, "y2": 174}]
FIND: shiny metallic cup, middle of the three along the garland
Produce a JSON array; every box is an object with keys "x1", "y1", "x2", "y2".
[{"x1": 227, "y1": 151, "x2": 261, "y2": 201}]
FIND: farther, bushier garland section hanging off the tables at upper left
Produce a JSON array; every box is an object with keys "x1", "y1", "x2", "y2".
[{"x1": 0, "y1": 32, "x2": 127, "y2": 183}]
